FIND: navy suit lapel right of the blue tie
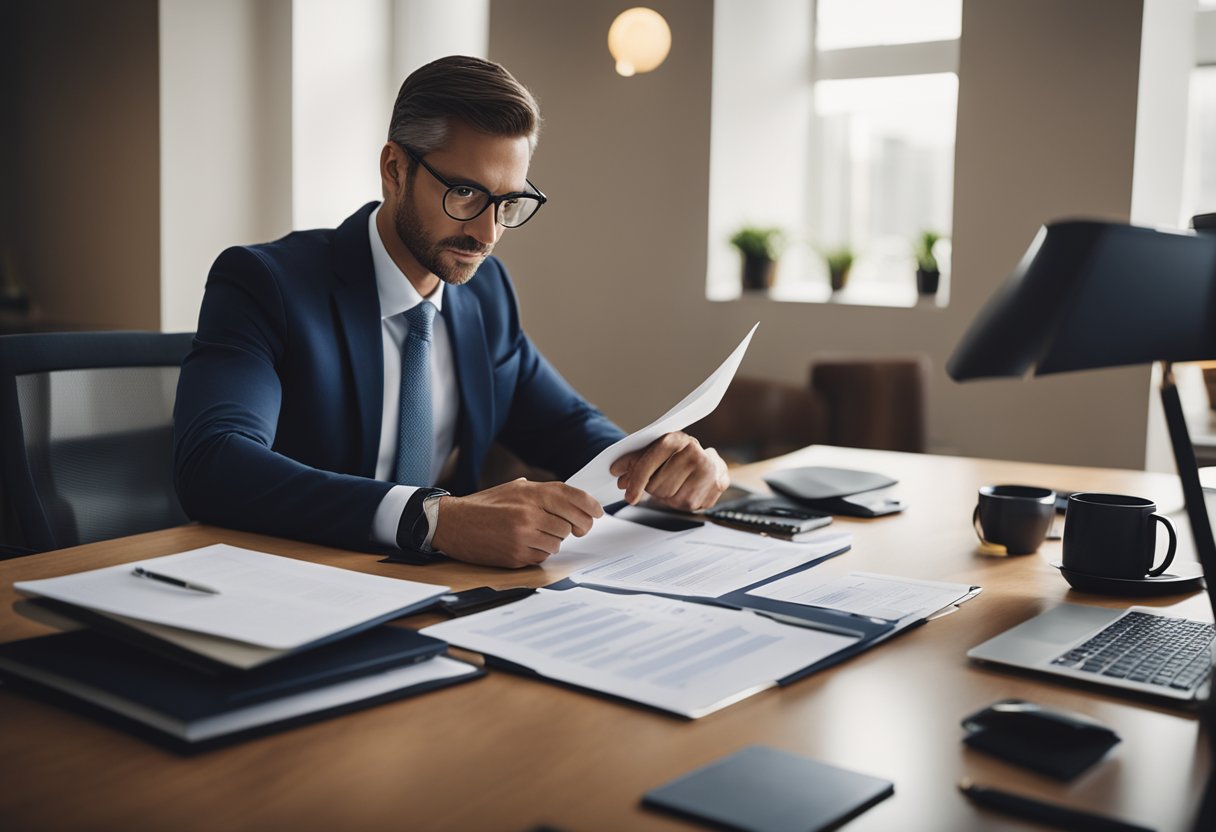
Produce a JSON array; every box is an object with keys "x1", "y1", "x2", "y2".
[{"x1": 443, "y1": 286, "x2": 495, "y2": 490}]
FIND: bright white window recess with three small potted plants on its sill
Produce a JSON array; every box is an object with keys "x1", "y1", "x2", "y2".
[{"x1": 706, "y1": 0, "x2": 962, "y2": 307}]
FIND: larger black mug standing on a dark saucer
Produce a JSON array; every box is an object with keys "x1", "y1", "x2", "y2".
[{"x1": 1063, "y1": 493, "x2": 1178, "y2": 580}]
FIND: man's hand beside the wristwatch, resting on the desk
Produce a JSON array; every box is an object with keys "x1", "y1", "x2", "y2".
[{"x1": 430, "y1": 478, "x2": 604, "y2": 568}]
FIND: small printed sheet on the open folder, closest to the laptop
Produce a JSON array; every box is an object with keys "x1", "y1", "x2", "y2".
[{"x1": 748, "y1": 570, "x2": 975, "y2": 622}]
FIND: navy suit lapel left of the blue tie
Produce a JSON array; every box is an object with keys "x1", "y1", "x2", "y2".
[{"x1": 332, "y1": 203, "x2": 384, "y2": 477}]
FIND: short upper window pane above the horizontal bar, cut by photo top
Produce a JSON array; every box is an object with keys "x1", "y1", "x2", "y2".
[{"x1": 815, "y1": 0, "x2": 963, "y2": 49}]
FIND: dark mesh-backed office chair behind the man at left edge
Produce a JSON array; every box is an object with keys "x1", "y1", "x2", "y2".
[{"x1": 0, "y1": 332, "x2": 193, "y2": 558}]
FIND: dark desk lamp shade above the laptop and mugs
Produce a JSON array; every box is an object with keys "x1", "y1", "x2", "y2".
[{"x1": 946, "y1": 220, "x2": 1216, "y2": 381}]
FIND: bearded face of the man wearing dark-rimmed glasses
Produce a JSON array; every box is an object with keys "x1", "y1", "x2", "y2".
[{"x1": 393, "y1": 122, "x2": 529, "y2": 286}]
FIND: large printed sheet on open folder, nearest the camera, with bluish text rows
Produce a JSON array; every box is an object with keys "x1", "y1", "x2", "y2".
[{"x1": 423, "y1": 588, "x2": 855, "y2": 718}]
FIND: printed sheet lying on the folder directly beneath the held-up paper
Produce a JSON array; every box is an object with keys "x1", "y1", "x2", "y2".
[{"x1": 553, "y1": 515, "x2": 852, "y2": 598}]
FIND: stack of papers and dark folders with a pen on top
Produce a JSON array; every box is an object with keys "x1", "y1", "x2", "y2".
[{"x1": 0, "y1": 545, "x2": 479, "y2": 748}]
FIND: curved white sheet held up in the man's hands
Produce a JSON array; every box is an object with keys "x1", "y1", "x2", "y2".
[{"x1": 565, "y1": 324, "x2": 760, "y2": 506}]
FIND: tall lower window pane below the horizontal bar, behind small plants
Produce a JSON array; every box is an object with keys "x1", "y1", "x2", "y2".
[{"x1": 810, "y1": 73, "x2": 958, "y2": 286}]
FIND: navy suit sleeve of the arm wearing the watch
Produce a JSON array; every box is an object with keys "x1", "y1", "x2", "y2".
[{"x1": 174, "y1": 248, "x2": 392, "y2": 550}]
